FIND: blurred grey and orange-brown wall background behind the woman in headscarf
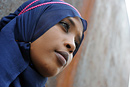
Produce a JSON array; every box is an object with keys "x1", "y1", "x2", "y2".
[{"x1": 0, "y1": 0, "x2": 130, "y2": 87}]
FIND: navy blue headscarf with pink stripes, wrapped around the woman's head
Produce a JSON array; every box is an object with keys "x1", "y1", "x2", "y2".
[{"x1": 0, "y1": 0, "x2": 87, "y2": 87}]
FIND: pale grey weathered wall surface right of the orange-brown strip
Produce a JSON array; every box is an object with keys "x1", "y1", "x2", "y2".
[{"x1": 73, "y1": 0, "x2": 130, "y2": 87}]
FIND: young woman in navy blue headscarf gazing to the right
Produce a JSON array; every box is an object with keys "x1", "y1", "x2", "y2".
[{"x1": 0, "y1": 0, "x2": 87, "y2": 87}]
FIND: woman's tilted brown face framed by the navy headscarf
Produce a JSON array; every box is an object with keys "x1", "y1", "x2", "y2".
[{"x1": 30, "y1": 17, "x2": 83, "y2": 77}]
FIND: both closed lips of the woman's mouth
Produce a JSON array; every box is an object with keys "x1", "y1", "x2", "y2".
[{"x1": 55, "y1": 51, "x2": 69, "y2": 66}]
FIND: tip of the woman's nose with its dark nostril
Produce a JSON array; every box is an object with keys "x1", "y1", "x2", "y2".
[{"x1": 64, "y1": 38, "x2": 75, "y2": 53}]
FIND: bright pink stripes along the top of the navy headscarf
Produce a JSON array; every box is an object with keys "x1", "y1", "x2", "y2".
[{"x1": 19, "y1": 0, "x2": 81, "y2": 16}]
